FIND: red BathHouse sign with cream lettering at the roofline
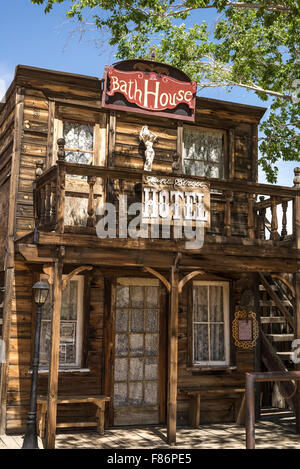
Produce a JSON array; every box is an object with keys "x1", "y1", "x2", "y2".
[{"x1": 103, "y1": 61, "x2": 197, "y2": 120}]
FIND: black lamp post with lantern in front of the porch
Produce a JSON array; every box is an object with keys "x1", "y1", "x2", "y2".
[{"x1": 22, "y1": 282, "x2": 49, "y2": 449}]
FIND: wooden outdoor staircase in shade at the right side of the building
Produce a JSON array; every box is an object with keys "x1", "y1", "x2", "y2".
[{"x1": 259, "y1": 273, "x2": 295, "y2": 409}]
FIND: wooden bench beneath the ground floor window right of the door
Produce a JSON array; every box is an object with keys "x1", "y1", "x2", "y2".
[{"x1": 179, "y1": 387, "x2": 245, "y2": 428}]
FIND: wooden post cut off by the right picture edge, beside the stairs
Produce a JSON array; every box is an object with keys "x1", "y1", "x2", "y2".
[{"x1": 293, "y1": 168, "x2": 300, "y2": 433}]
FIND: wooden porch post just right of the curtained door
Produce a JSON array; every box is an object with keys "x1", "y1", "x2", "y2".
[{"x1": 167, "y1": 266, "x2": 178, "y2": 446}]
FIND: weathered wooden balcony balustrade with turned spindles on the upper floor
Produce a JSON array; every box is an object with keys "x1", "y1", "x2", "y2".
[{"x1": 35, "y1": 139, "x2": 300, "y2": 242}]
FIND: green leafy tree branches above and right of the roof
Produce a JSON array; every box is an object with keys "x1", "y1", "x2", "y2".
[{"x1": 31, "y1": 0, "x2": 300, "y2": 182}]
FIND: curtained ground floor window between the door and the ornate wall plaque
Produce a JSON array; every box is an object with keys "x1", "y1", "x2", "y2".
[{"x1": 190, "y1": 281, "x2": 230, "y2": 367}]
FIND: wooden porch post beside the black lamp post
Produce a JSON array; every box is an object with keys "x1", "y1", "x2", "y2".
[{"x1": 46, "y1": 247, "x2": 63, "y2": 449}]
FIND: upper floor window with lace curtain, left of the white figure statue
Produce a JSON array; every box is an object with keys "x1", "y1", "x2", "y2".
[{"x1": 63, "y1": 121, "x2": 94, "y2": 164}]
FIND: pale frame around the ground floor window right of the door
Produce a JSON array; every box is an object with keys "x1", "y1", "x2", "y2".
[{"x1": 192, "y1": 280, "x2": 230, "y2": 368}]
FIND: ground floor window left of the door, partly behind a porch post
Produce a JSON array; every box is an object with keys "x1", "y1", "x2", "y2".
[{"x1": 40, "y1": 276, "x2": 84, "y2": 369}]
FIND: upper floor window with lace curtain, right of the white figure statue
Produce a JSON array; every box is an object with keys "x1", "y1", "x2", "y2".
[{"x1": 183, "y1": 126, "x2": 224, "y2": 178}]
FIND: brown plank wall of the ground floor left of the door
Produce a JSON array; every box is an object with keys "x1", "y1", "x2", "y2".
[{"x1": 6, "y1": 257, "x2": 104, "y2": 432}]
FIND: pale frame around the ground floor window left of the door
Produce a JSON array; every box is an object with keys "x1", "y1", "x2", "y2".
[{"x1": 39, "y1": 275, "x2": 84, "y2": 371}]
